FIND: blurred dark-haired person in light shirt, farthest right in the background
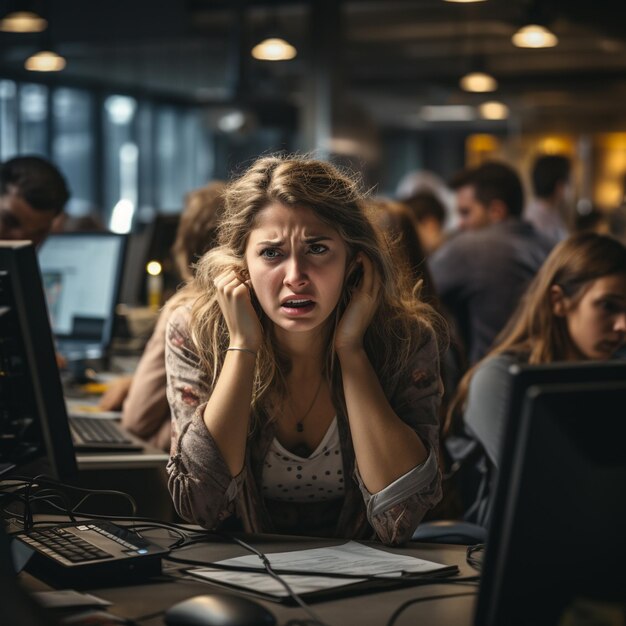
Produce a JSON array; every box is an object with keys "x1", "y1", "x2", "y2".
[{"x1": 524, "y1": 154, "x2": 573, "y2": 243}]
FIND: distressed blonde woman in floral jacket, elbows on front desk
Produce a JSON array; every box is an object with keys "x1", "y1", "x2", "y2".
[{"x1": 166, "y1": 157, "x2": 442, "y2": 544}]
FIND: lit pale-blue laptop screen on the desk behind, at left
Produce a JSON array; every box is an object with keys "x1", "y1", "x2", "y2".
[{"x1": 38, "y1": 233, "x2": 125, "y2": 357}]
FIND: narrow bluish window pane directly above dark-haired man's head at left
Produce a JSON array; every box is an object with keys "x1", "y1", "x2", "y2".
[{"x1": 19, "y1": 83, "x2": 48, "y2": 156}]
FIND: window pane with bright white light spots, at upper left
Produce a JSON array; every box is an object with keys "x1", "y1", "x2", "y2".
[{"x1": 103, "y1": 95, "x2": 139, "y2": 233}]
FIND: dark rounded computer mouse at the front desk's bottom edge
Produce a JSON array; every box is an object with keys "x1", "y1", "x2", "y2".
[{"x1": 165, "y1": 593, "x2": 276, "y2": 626}]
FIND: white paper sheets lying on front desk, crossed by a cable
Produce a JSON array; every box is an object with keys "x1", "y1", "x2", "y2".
[{"x1": 190, "y1": 541, "x2": 447, "y2": 596}]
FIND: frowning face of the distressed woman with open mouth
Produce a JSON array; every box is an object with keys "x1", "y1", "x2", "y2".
[{"x1": 245, "y1": 203, "x2": 348, "y2": 332}]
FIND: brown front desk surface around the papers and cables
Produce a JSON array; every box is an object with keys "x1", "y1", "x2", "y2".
[{"x1": 21, "y1": 531, "x2": 477, "y2": 626}]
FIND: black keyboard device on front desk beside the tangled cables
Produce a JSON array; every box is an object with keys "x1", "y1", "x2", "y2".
[{"x1": 14, "y1": 521, "x2": 167, "y2": 584}]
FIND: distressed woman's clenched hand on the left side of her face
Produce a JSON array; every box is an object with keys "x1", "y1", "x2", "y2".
[{"x1": 215, "y1": 269, "x2": 263, "y2": 352}]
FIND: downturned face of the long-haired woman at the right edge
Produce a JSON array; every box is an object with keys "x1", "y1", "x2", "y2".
[{"x1": 557, "y1": 274, "x2": 626, "y2": 360}]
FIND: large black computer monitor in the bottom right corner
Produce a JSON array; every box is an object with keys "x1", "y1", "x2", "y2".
[{"x1": 474, "y1": 380, "x2": 626, "y2": 626}]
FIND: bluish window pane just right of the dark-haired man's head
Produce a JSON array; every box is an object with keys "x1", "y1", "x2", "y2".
[{"x1": 52, "y1": 88, "x2": 100, "y2": 215}]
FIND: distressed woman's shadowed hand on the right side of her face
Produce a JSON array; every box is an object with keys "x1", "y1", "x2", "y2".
[{"x1": 335, "y1": 252, "x2": 380, "y2": 354}]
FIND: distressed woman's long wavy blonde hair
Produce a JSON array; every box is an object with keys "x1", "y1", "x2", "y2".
[{"x1": 180, "y1": 156, "x2": 445, "y2": 426}]
